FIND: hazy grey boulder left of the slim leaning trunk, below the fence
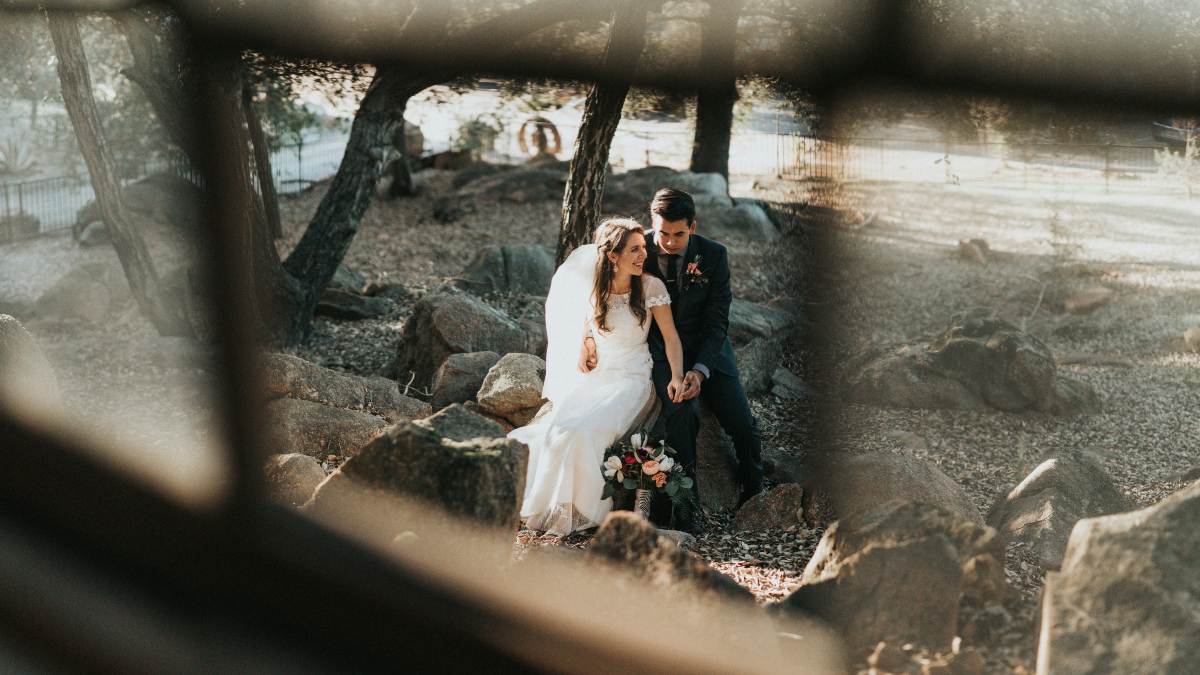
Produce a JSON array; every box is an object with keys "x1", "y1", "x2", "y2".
[{"x1": 35, "y1": 262, "x2": 133, "y2": 323}]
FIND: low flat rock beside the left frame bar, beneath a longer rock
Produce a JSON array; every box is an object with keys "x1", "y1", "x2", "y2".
[{"x1": 266, "y1": 399, "x2": 388, "y2": 458}]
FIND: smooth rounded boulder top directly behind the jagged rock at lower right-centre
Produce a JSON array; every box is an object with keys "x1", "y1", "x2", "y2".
[{"x1": 814, "y1": 452, "x2": 983, "y2": 525}]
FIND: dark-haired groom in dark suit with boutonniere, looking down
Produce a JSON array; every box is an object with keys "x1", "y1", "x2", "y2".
[{"x1": 646, "y1": 187, "x2": 762, "y2": 530}]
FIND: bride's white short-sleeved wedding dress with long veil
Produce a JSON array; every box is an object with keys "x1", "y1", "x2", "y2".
[{"x1": 509, "y1": 246, "x2": 671, "y2": 536}]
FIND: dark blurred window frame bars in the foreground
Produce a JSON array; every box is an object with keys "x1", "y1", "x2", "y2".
[{"x1": 0, "y1": 0, "x2": 1200, "y2": 671}]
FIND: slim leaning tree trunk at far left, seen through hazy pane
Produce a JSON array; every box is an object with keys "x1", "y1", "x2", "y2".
[{"x1": 47, "y1": 12, "x2": 192, "y2": 336}]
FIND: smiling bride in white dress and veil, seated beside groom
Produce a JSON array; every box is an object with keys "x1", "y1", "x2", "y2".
[{"x1": 509, "y1": 219, "x2": 683, "y2": 536}]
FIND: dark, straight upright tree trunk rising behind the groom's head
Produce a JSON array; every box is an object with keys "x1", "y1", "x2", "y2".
[{"x1": 690, "y1": 0, "x2": 742, "y2": 179}]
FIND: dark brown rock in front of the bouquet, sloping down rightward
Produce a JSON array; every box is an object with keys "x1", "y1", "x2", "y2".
[{"x1": 587, "y1": 510, "x2": 754, "y2": 603}]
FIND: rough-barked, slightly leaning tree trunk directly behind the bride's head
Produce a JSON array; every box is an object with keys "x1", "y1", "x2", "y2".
[{"x1": 556, "y1": 0, "x2": 646, "y2": 264}]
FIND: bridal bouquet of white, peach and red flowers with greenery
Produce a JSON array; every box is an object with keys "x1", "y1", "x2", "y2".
[{"x1": 601, "y1": 434, "x2": 692, "y2": 515}]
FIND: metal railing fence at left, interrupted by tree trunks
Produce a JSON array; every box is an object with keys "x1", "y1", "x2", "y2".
[{"x1": 0, "y1": 136, "x2": 346, "y2": 241}]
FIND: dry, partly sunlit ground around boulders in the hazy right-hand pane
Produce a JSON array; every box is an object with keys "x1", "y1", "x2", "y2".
[{"x1": 818, "y1": 177, "x2": 1200, "y2": 671}]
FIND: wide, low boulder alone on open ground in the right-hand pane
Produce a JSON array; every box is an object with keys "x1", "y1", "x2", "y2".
[{"x1": 844, "y1": 318, "x2": 1099, "y2": 416}]
